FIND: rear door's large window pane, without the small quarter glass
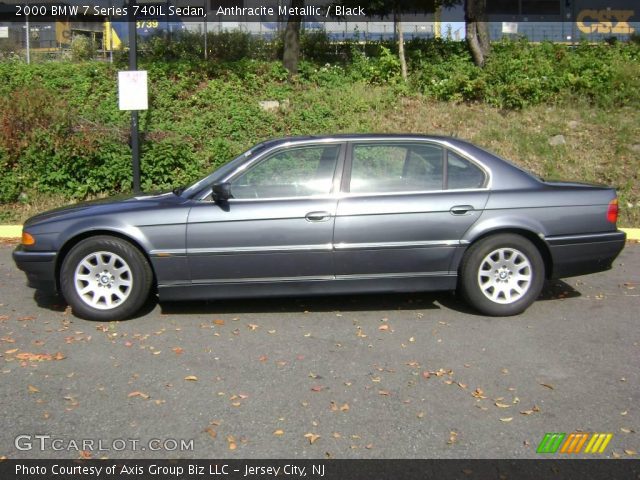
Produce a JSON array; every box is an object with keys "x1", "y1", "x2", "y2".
[{"x1": 349, "y1": 143, "x2": 444, "y2": 193}]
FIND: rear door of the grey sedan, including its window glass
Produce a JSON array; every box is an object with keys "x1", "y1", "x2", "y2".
[{"x1": 334, "y1": 141, "x2": 489, "y2": 278}]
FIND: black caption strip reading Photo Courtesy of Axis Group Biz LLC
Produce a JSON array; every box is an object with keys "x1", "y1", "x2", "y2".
[{"x1": 0, "y1": 459, "x2": 640, "y2": 480}]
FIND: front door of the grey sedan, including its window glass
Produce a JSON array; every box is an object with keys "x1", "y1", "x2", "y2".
[{"x1": 187, "y1": 144, "x2": 343, "y2": 284}]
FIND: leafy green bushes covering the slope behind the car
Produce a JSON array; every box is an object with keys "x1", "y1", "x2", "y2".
[{"x1": 0, "y1": 32, "x2": 640, "y2": 203}]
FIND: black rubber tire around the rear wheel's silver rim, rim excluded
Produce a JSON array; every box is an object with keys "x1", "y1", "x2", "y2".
[{"x1": 460, "y1": 234, "x2": 545, "y2": 317}]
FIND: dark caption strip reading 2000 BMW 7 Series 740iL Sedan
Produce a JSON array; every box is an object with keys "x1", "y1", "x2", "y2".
[{"x1": 0, "y1": 0, "x2": 640, "y2": 23}]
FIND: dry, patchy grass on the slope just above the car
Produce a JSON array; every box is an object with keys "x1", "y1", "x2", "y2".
[{"x1": 0, "y1": 88, "x2": 640, "y2": 227}]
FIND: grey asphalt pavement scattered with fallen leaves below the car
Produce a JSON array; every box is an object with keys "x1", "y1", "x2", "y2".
[{"x1": 0, "y1": 243, "x2": 640, "y2": 459}]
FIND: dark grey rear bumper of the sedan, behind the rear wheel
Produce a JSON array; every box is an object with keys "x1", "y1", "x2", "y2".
[{"x1": 546, "y1": 230, "x2": 627, "y2": 278}]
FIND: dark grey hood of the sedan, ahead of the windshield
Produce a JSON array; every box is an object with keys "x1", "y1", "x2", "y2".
[{"x1": 24, "y1": 192, "x2": 184, "y2": 227}]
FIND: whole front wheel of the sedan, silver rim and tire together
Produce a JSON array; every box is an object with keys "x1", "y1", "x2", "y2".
[{"x1": 60, "y1": 236, "x2": 153, "y2": 322}]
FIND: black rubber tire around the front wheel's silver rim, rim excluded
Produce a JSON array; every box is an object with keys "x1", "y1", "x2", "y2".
[{"x1": 60, "y1": 236, "x2": 152, "y2": 321}]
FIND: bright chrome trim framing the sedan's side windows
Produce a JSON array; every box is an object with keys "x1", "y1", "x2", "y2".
[{"x1": 195, "y1": 137, "x2": 493, "y2": 202}]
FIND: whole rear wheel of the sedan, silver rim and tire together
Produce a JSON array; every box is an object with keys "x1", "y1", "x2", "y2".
[{"x1": 459, "y1": 233, "x2": 545, "y2": 317}]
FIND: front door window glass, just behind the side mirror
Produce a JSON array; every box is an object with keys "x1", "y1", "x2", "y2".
[{"x1": 231, "y1": 145, "x2": 340, "y2": 199}]
